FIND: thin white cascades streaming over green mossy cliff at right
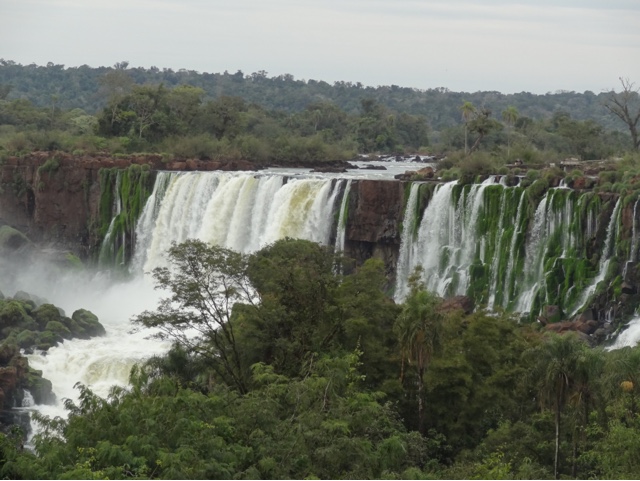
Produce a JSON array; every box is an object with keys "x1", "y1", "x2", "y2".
[{"x1": 395, "y1": 178, "x2": 621, "y2": 316}]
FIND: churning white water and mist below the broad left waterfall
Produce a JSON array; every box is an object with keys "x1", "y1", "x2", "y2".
[{"x1": 18, "y1": 272, "x2": 168, "y2": 429}]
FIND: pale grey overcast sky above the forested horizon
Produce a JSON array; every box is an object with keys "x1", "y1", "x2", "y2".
[{"x1": 0, "y1": 0, "x2": 640, "y2": 93}]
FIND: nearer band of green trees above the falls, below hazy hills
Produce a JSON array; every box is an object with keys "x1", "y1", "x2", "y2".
[{"x1": 0, "y1": 62, "x2": 640, "y2": 166}]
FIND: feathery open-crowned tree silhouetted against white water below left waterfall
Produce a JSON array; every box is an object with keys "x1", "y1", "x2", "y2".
[{"x1": 133, "y1": 240, "x2": 259, "y2": 393}]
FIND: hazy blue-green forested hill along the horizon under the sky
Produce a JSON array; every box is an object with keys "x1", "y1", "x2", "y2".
[{"x1": 0, "y1": 59, "x2": 625, "y2": 131}]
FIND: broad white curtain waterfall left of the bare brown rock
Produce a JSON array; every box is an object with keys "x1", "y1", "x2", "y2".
[{"x1": 133, "y1": 172, "x2": 350, "y2": 272}]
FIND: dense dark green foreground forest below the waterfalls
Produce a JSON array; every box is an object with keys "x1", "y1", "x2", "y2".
[{"x1": 0, "y1": 239, "x2": 640, "y2": 479}]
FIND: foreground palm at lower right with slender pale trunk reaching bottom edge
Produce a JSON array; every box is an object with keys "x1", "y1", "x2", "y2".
[{"x1": 527, "y1": 333, "x2": 589, "y2": 479}]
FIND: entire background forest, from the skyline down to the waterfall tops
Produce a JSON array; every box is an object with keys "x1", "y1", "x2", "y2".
[{"x1": 0, "y1": 60, "x2": 638, "y2": 165}]
